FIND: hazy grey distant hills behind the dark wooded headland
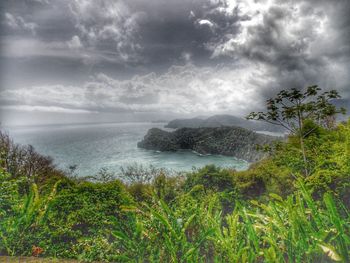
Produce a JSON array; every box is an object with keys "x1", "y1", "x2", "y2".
[{"x1": 164, "y1": 114, "x2": 284, "y2": 132}]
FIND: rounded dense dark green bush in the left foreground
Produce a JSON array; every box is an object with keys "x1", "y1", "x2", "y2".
[{"x1": 40, "y1": 181, "x2": 133, "y2": 257}]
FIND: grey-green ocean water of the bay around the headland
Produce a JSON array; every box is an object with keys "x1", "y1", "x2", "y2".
[{"x1": 4, "y1": 123, "x2": 248, "y2": 176}]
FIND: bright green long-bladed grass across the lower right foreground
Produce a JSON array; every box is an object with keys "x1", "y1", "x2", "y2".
[{"x1": 117, "y1": 182, "x2": 350, "y2": 262}]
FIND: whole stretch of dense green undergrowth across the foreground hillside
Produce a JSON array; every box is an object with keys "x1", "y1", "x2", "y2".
[{"x1": 0, "y1": 120, "x2": 350, "y2": 262}]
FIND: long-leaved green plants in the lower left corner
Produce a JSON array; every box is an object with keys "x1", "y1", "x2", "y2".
[{"x1": 0, "y1": 173, "x2": 59, "y2": 255}]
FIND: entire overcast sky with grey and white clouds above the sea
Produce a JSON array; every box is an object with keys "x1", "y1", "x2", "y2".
[{"x1": 0, "y1": 0, "x2": 350, "y2": 124}]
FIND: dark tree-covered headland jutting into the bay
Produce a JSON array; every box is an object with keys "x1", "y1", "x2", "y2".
[{"x1": 137, "y1": 127, "x2": 280, "y2": 162}]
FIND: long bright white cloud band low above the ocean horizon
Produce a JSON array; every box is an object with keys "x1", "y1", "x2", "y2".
[{"x1": 0, "y1": 64, "x2": 265, "y2": 114}]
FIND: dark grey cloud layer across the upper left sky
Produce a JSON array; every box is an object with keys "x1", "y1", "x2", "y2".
[{"x1": 1, "y1": 0, "x2": 235, "y2": 68}]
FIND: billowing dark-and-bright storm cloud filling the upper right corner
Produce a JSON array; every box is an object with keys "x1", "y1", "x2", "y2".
[{"x1": 201, "y1": 0, "x2": 350, "y2": 100}]
